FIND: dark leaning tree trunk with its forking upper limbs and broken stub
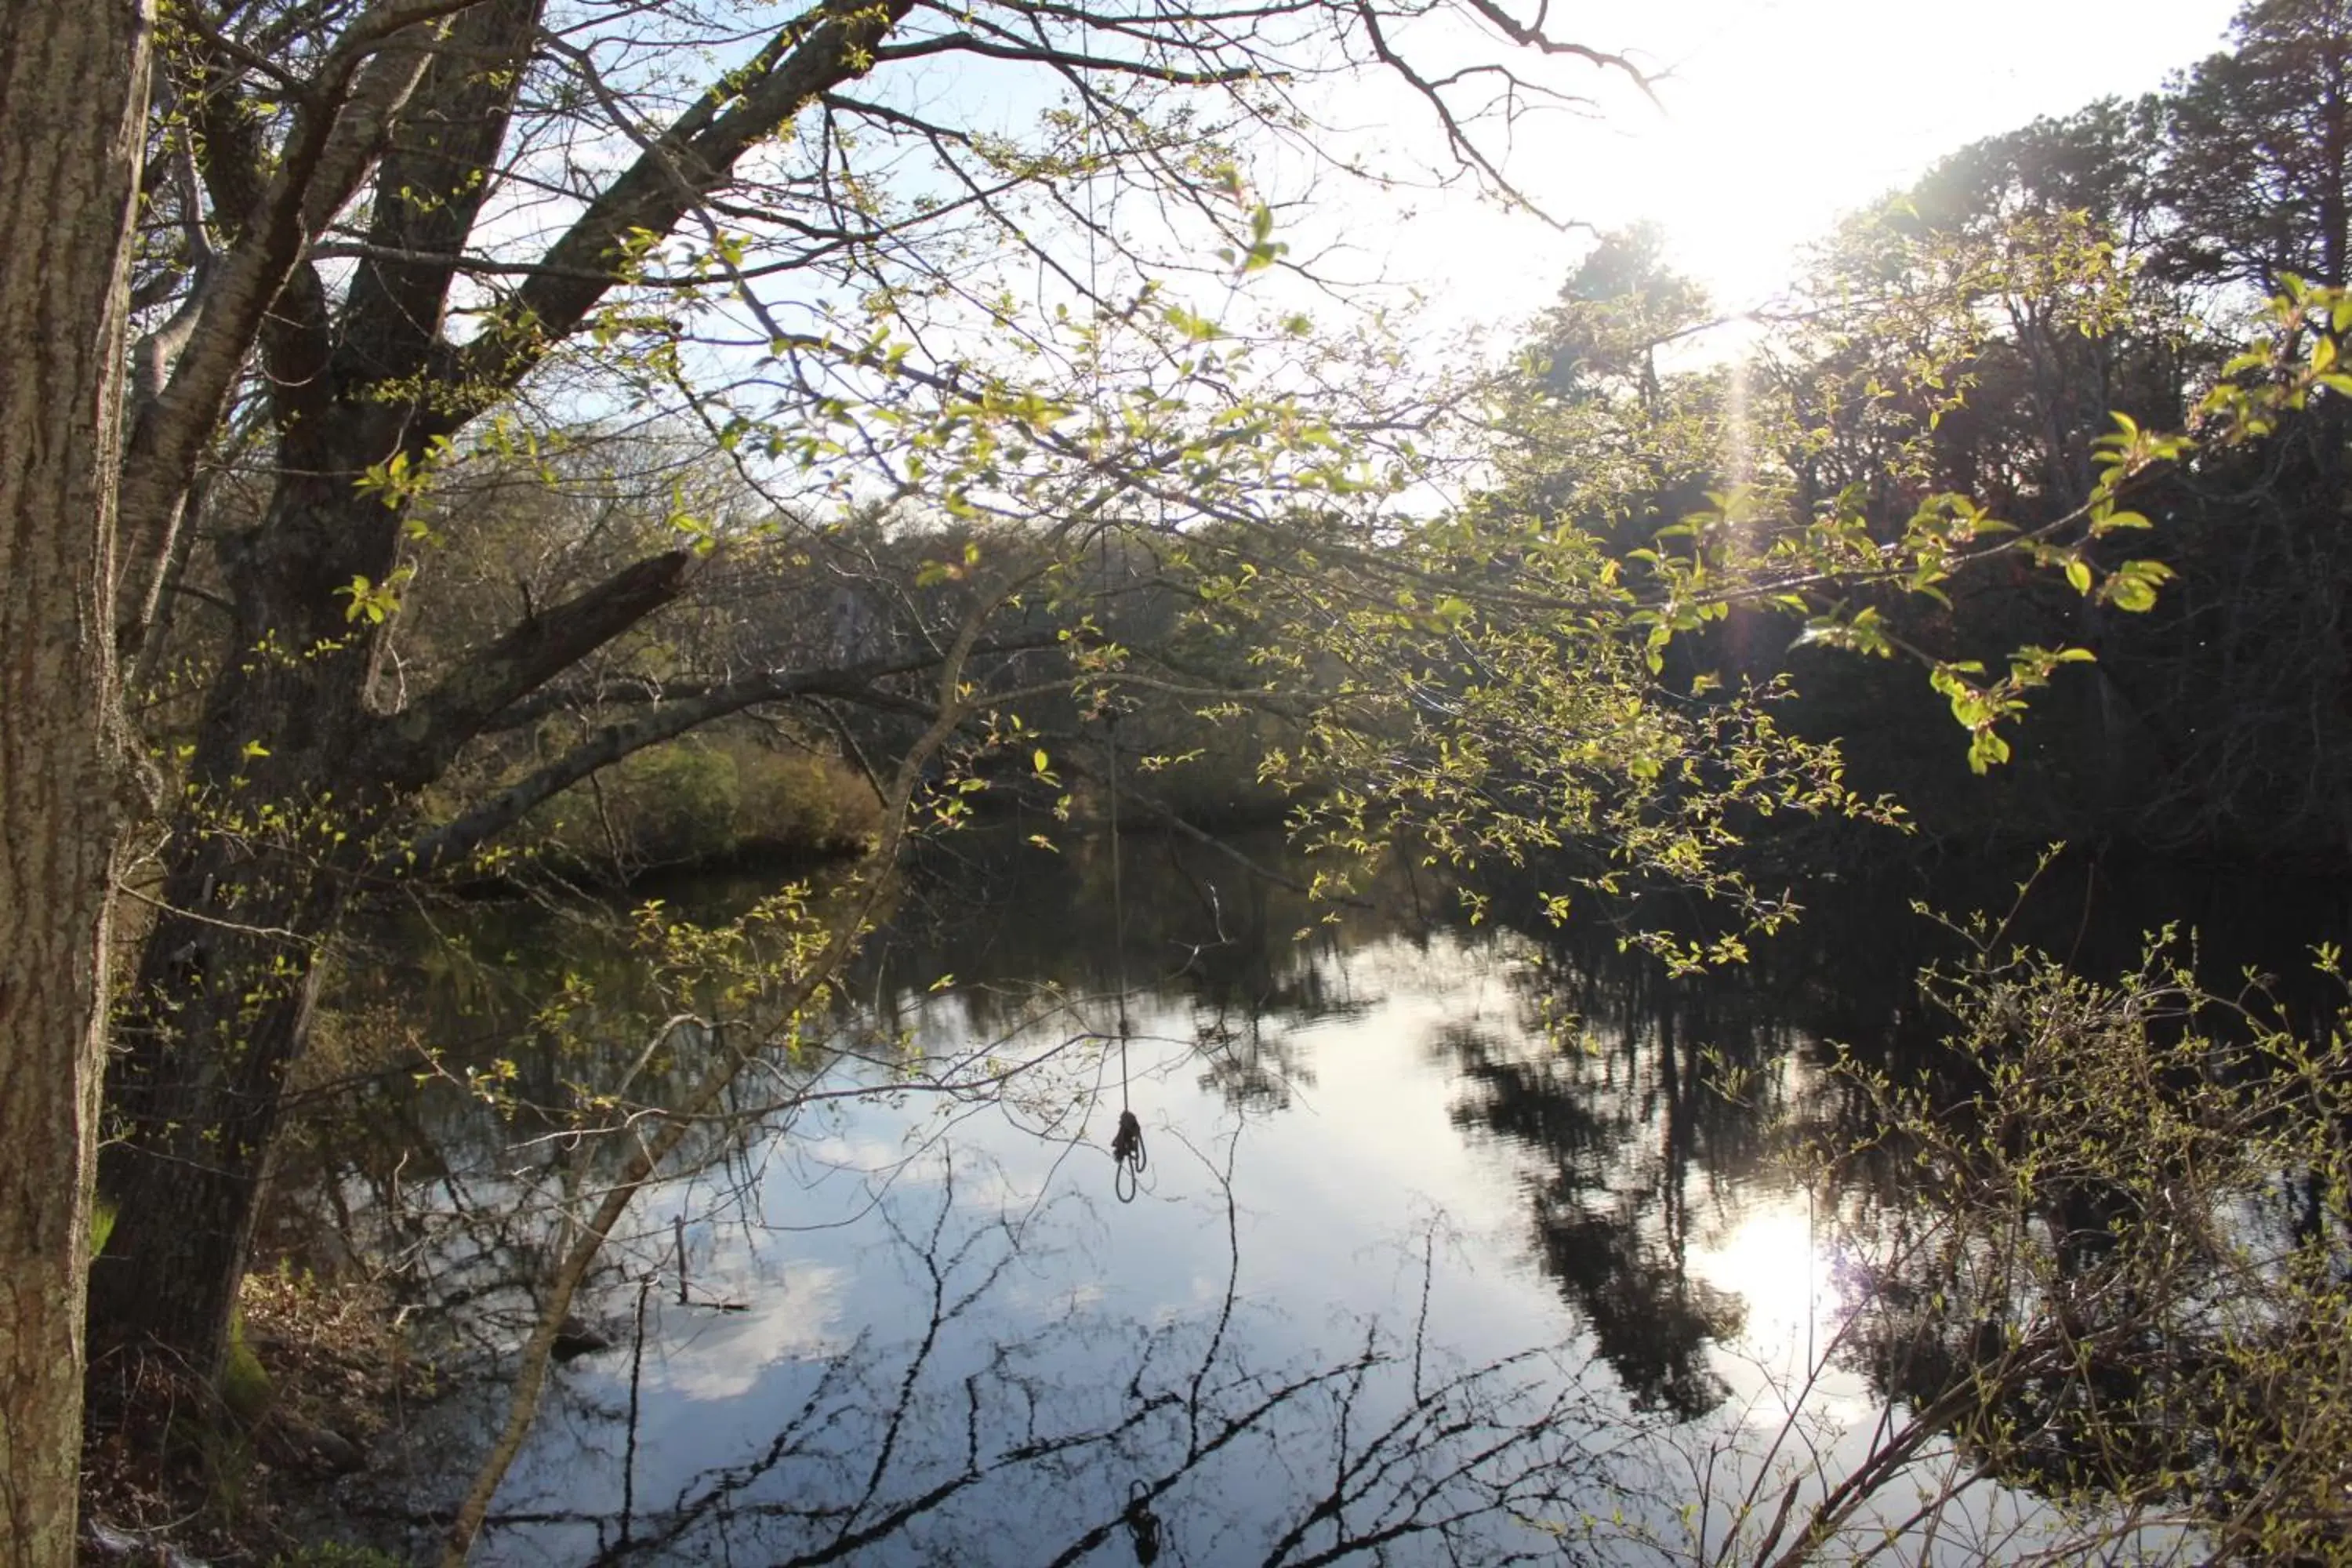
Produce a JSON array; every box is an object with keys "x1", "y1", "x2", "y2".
[{"x1": 89, "y1": 0, "x2": 910, "y2": 1375}]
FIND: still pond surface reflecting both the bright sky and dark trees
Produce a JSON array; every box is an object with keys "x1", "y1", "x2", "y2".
[{"x1": 322, "y1": 841, "x2": 2343, "y2": 1566}]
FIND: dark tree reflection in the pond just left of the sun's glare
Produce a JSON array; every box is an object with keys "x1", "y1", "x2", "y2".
[{"x1": 1437, "y1": 865, "x2": 2211, "y2": 1415}]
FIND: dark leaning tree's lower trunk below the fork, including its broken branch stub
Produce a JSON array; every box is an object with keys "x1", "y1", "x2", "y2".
[{"x1": 89, "y1": 453, "x2": 691, "y2": 1382}]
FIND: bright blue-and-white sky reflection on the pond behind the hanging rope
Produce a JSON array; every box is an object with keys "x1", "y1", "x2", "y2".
[{"x1": 353, "y1": 907, "x2": 2136, "y2": 1563}]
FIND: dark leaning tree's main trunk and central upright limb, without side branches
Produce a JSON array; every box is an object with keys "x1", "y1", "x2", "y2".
[{"x1": 89, "y1": 0, "x2": 539, "y2": 1382}]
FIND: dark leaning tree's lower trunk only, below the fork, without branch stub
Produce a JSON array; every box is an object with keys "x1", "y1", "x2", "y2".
[{"x1": 89, "y1": 475, "x2": 390, "y2": 1382}]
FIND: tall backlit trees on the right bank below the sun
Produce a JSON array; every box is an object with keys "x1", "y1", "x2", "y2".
[{"x1": 1505, "y1": 2, "x2": 2352, "y2": 860}]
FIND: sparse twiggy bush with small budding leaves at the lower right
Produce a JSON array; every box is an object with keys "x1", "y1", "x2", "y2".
[{"x1": 1823, "y1": 926, "x2": 2352, "y2": 1563}]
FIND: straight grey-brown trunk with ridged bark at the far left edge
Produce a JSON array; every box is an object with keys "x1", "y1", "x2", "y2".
[{"x1": 0, "y1": 0, "x2": 151, "y2": 1568}]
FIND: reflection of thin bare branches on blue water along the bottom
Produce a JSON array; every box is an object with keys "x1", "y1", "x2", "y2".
[{"x1": 353, "y1": 1147, "x2": 1672, "y2": 1568}]
